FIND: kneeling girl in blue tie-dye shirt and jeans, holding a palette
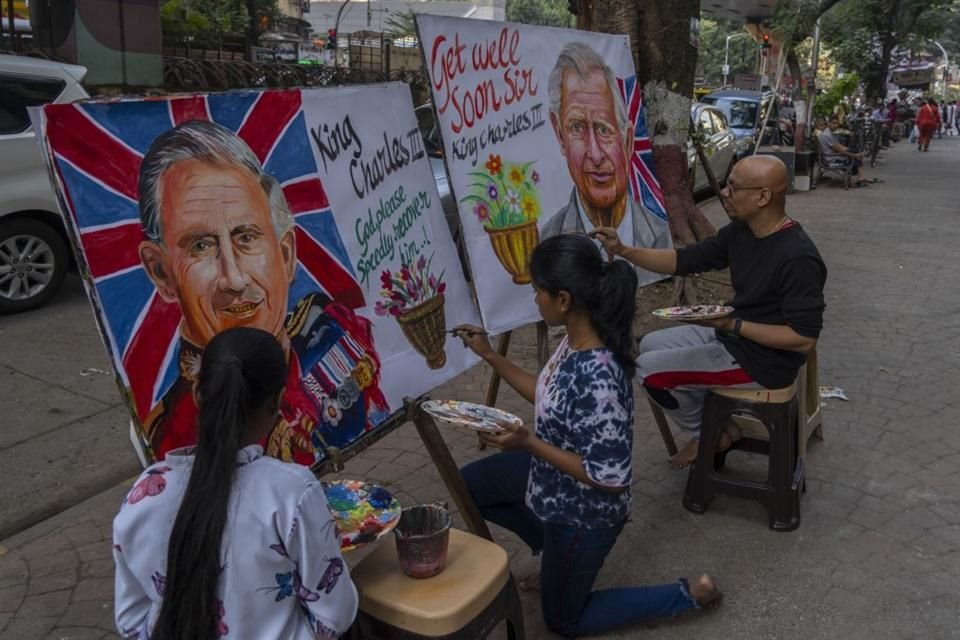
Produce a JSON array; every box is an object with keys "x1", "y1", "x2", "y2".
[{"x1": 456, "y1": 234, "x2": 720, "y2": 638}]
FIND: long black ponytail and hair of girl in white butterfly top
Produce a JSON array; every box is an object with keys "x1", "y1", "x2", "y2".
[{"x1": 151, "y1": 327, "x2": 287, "y2": 640}]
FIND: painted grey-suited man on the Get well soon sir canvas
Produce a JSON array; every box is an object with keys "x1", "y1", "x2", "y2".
[{"x1": 540, "y1": 42, "x2": 670, "y2": 284}]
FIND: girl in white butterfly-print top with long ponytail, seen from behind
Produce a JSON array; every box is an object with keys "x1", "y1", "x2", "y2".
[{"x1": 113, "y1": 328, "x2": 357, "y2": 640}]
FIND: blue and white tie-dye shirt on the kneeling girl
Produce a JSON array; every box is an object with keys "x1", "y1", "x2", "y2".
[{"x1": 526, "y1": 338, "x2": 633, "y2": 529}]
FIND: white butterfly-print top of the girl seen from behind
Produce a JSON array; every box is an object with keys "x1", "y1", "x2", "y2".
[{"x1": 113, "y1": 445, "x2": 357, "y2": 640}]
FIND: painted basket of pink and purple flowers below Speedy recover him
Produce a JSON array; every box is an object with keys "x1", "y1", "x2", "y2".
[{"x1": 374, "y1": 251, "x2": 447, "y2": 369}]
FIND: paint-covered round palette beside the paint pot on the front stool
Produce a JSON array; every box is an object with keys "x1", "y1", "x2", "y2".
[{"x1": 321, "y1": 480, "x2": 402, "y2": 551}]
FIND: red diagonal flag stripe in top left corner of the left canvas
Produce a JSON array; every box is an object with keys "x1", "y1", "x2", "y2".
[{"x1": 44, "y1": 104, "x2": 141, "y2": 200}]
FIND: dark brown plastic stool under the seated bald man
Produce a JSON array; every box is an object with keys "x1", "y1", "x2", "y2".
[{"x1": 683, "y1": 384, "x2": 804, "y2": 531}]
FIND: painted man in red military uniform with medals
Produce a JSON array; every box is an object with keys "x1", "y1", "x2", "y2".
[{"x1": 139, "y1": 121, "x2": 388, "y2": 464}]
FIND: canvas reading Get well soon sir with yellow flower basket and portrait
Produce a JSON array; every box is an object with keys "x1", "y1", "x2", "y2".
[{"x1": 417, "y1": 14, "x2": 671, "y2": 333}]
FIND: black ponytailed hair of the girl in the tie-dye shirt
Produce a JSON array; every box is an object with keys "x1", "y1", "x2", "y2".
[{"x1": 530, "y1": 233, "x2": 637, "y2": 378}]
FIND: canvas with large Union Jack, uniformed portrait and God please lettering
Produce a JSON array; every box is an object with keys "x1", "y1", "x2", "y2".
[{"x1": 38, "y1": 84, "x2": 478, "y2": 464}]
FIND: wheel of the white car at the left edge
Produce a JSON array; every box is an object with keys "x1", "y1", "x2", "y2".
[{"x1": 0, "y1": 218, "x2": 69, "y2": 314}]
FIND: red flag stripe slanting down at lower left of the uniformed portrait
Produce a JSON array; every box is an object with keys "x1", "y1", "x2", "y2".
[{"x1": 123, "y1": 294, "x2": 182, "y2": 421}]
